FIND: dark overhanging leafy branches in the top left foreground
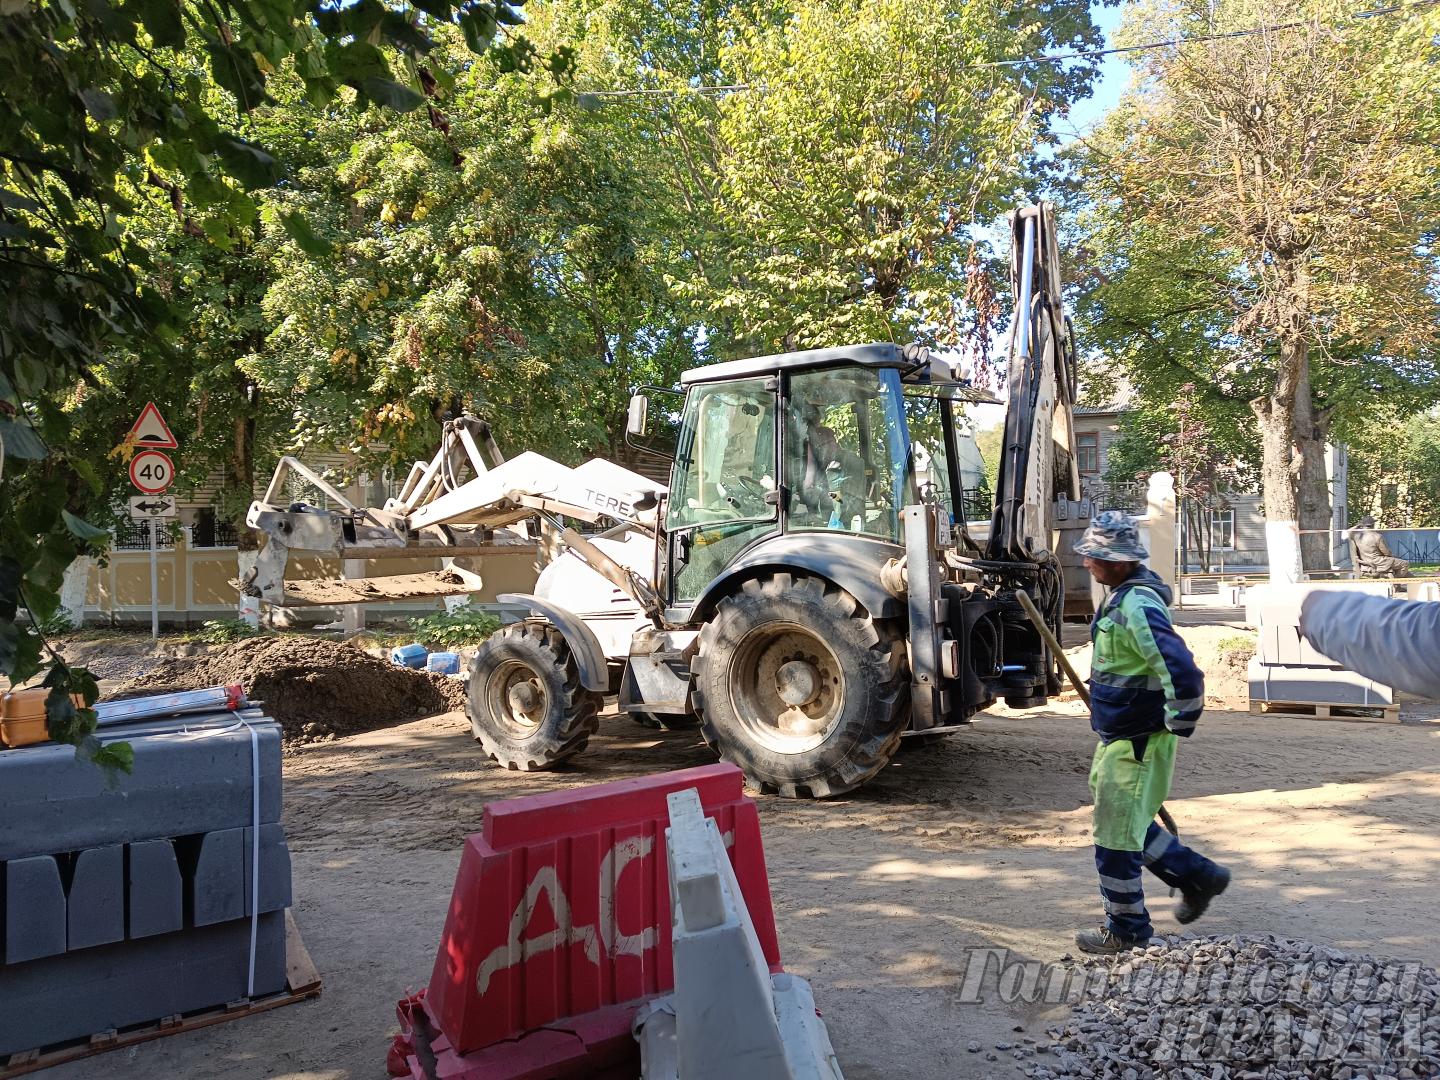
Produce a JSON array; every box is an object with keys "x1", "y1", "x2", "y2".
[{"x1": 0, "y1": 0, "x2": 569, "y2": 765}]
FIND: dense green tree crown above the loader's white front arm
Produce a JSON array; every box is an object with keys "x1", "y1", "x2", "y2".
[{"x1": 260, "y1": 12, "x2": 697, "y2": 472}]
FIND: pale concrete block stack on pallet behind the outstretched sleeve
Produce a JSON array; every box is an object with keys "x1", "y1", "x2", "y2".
[{"x1": 1246, "y1": 582, "x2": 1395, "y2": 706}]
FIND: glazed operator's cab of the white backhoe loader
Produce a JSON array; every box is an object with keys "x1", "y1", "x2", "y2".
[{"x1": 653, "y1": 355, "x2": 992, "y2": 615}]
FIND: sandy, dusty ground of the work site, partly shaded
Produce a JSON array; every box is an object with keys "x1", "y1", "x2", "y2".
[{"x1": 48, "y1": 688, "x2": 1440, "y2": 1080}]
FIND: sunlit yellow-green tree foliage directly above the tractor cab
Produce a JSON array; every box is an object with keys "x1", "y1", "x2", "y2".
[{"x1": 654, "y1": 0, "x2": 1099, "y2": 361}]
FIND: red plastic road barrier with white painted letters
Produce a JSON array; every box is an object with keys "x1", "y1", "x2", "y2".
[{"x1": 425, "y1": 763, "x2": 780, "y2": 1054}]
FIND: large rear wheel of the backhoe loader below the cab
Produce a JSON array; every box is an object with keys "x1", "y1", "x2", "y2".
[{"x1": 691, "y1": 573, "x2": 910, "y2": 799}]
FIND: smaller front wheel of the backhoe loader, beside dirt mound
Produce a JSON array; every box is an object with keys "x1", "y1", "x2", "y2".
[{"x1": 468, "y1": 621, "x2": 603, "y2": 772}]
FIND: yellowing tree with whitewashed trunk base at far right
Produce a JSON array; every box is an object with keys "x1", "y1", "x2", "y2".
[{"x1": 1083, "y1": 0, "x2": 1440, "y2": 575}]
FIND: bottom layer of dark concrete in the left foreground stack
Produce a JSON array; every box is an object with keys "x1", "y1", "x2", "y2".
[{"x1": 0, "y1": 912, "x2": 285, "y2": 1071}]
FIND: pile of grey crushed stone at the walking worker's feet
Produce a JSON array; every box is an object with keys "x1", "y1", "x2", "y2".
[{"x1": 1007, "y1": 935, "x2": 1440, "y2": 1080}]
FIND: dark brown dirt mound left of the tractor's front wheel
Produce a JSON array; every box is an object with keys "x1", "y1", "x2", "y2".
[{"x1": 115, "y1": 635, "x2": 465, "y2": 743}]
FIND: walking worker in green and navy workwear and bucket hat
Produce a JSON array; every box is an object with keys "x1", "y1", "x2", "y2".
[{"x1": 1076, "y1": 510, "x2": 1230, "y2": 953}]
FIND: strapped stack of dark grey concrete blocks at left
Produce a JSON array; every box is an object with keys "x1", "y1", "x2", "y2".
[{"x1": 0, "y1": 710, "x2": 291, "y2": 1057}]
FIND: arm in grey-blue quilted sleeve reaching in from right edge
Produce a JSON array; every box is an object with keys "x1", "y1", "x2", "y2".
[{"x1": 1300, "y1": 592, "x2": 1440, "y2": 697}]
